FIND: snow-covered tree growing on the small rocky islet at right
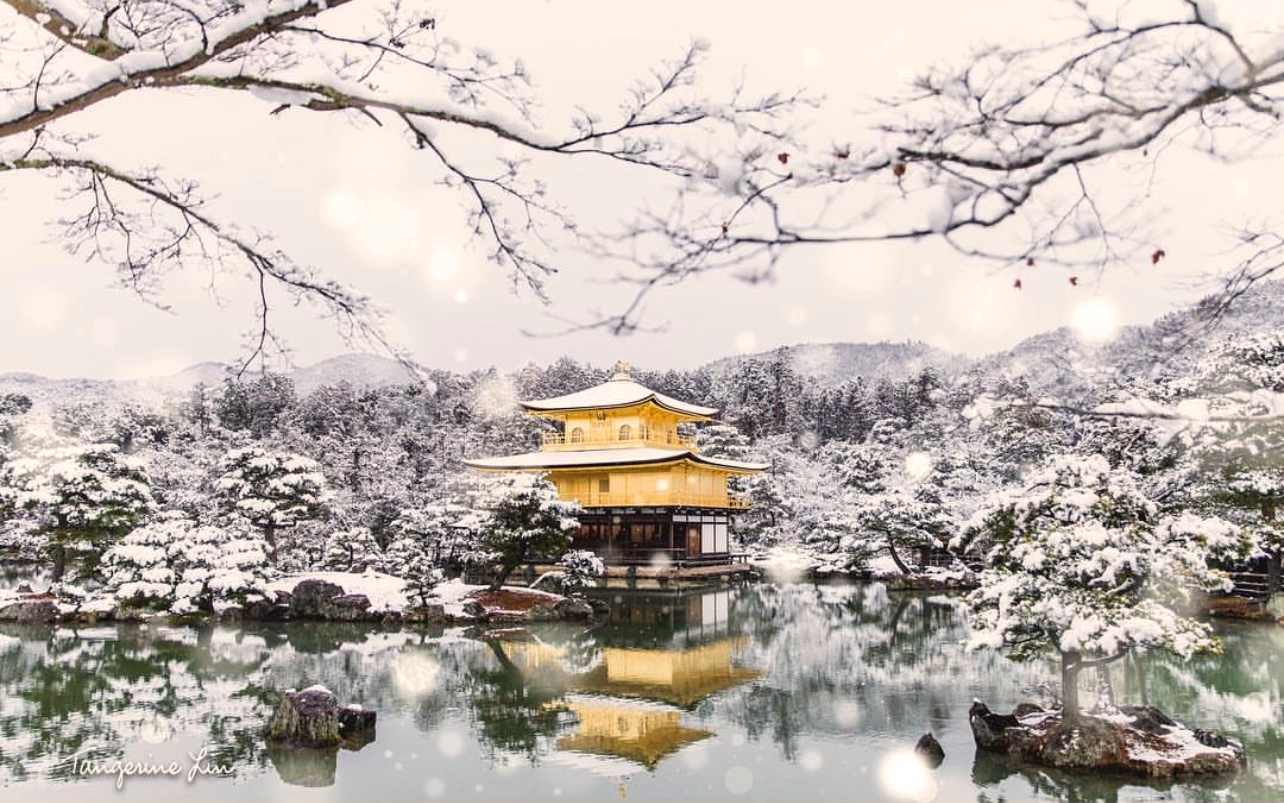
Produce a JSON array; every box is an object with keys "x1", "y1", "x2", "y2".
[{"x1": 968, "y1": 455, "x2": 1247, "y2": 721}]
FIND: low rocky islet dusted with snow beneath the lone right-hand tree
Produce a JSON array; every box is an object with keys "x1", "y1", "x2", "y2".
[{"x1": 968, "y1": 700, "x2": 1245, "y2": 779}]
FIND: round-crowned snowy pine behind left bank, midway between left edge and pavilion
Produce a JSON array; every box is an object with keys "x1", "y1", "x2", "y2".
[{"x1": 214, "y1": 446, "x2": 330, "y2": 560}]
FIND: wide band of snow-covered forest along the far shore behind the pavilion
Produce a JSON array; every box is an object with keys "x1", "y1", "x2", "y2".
[{"x1": 0, "y1": 303, "x2": 1284, "y2": 653}]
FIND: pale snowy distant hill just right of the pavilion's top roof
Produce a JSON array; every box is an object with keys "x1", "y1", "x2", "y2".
[{"x1": 706, "y1": 340, "x2": 973, "y2": 384}]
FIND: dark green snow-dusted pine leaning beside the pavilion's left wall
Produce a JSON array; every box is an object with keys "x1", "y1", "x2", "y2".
[{"x1": 474, "y1": 474, "x2": 580, "y2": 590}]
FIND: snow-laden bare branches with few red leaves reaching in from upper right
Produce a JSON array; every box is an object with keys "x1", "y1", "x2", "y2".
[{"x1": 603, "y1": 0, "x2": 1284, "y2": 329}]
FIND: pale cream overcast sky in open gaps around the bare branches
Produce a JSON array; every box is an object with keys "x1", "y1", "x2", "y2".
[{"x1": 0, "y1": 0, "x2": 1284, "y2": 378}]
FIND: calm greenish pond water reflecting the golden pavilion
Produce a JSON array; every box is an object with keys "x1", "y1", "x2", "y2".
[{"x1": 0, "y1": 583, "x2": 1284, "y2": 802}]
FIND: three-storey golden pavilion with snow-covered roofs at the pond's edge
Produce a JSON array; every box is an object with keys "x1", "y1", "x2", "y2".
[{"x1": 465, "y1": 362, "x2": 768, "y2": 567}]
